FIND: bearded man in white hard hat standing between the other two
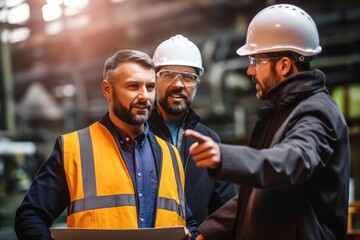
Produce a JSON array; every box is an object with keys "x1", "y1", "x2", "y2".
[{"x1": 149, "y1": 35, "x2": 236, "y2": 224}]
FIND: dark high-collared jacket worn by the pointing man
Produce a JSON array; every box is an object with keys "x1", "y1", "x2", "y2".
[{"x1": 199, "y1": 70, "x2": 350, "y2": 240}]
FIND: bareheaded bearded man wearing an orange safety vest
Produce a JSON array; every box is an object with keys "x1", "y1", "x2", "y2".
[{"x1": 15, "y1": 50, "x2": 196, "y2": 240}]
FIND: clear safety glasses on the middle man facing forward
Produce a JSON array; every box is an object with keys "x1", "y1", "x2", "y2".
[{"x1": 156, "y1": 69, "x2": 200, "y2": 87}]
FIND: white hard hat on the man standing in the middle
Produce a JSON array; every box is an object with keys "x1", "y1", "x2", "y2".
[{"x1": 153, "y1": 34, "x2": 204, "y2": 76}]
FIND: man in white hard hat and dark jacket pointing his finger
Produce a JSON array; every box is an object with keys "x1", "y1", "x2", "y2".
[{"x1": 185, "y1": 4, "x2": 350, "y2": 240}]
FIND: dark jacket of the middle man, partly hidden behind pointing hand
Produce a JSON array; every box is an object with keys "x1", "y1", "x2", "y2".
[{"x1": 148, "y1": 108, "x2": 236, "y2": 224}]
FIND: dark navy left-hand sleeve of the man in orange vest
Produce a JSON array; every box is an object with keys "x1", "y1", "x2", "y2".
[{"x1": 15, "y1": 137, "x2": 70, "y2": 240}]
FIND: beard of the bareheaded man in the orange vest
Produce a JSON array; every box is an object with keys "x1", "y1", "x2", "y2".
[{"x1": 113, "y1": 91, "x2": 154, "y2": 125}]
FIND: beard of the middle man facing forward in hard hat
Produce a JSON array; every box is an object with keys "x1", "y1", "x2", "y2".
[{"x1": 158, "y1": 90, "x2": 191, "y2": 116}]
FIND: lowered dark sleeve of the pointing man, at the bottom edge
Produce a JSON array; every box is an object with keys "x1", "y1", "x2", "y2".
[{"x1": 199, "y1": 196, "x2": 238, "y2": 240}]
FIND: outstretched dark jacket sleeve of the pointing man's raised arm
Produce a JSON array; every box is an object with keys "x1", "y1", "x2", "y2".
[{"x1": 209, "y1": 112, "x2": 340, "y2": 189}]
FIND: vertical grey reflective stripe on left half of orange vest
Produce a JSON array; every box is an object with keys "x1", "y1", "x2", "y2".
[{"x1": 78, "y1": 128, "x2": 96, "y2": 198}]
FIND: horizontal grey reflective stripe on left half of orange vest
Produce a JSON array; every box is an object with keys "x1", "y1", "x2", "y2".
[{"x1": 69, "y1": 194, "x2": 136, "y2": 214}]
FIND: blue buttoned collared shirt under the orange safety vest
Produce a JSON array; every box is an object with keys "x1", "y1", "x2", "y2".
[{"x1": 117, "y1": 124, "x2": 158, "y2": 228}]
